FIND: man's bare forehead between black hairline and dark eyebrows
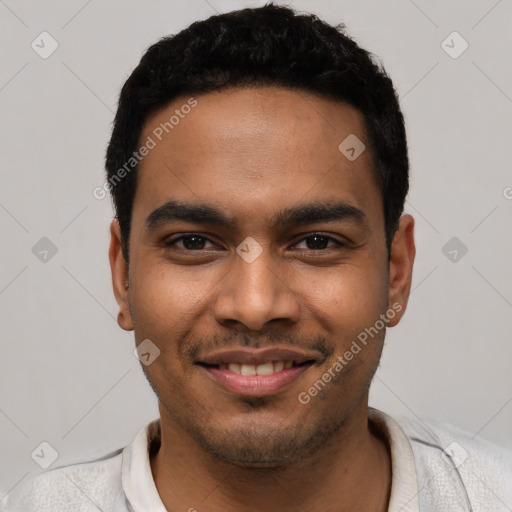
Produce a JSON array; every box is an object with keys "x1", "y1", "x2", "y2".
[{"x1": 134, "y1": 87, "x2": 381, "y2": 230}]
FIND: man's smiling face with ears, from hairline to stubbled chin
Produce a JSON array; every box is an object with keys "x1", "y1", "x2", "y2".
[{"x1": 110, "y1": 87, "x2": 414, "y2": 466}]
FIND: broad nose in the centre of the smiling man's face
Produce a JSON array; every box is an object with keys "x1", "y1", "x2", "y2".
[{"x1": 213, "y1": 250, "x2": 300, "y2": 331}]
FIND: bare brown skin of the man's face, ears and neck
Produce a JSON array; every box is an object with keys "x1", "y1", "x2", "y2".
[{"x1": 109, "y1": 87, "x2": 415, "y2": 512}]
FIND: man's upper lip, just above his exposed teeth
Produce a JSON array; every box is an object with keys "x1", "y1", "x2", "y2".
[{"x1": 197, "y1": 347, "x2": 319, "y2": 365}]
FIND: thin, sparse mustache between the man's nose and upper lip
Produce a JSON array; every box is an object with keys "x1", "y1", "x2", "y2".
[{"x1": 182, "y1": 332, "x2": 334, "y2": 362}]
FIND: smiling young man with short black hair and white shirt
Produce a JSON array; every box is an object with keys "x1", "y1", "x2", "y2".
[{"x1": 6, "y1": 5, "x2": 512, "y2": 512}]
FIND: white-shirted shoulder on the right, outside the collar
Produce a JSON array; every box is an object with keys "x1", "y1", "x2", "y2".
[{"x1": 395, "y1": 418, "x2": 512, "y2": 511}]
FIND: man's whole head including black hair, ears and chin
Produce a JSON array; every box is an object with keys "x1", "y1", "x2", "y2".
[{"x1": 106, "y1": 5, "x2": 414, "y2": 465}]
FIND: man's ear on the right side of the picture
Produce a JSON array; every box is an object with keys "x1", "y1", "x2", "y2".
[{"x1": 388, "y1": 215, "x2": 416, "y2": 327}]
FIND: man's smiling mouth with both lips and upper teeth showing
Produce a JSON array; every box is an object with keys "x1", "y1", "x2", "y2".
[{"x1": 196, "y1": 349, "x2": 318, "y2": 396}]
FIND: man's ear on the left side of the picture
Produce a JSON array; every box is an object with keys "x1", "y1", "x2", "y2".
[{"x1": 108, "y1": 219, "x2": 133, "y2": 331}]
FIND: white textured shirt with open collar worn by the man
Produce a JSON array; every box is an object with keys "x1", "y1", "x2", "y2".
[{"x1": 0, "y1": 408, "x2": 512, "y2": 512}]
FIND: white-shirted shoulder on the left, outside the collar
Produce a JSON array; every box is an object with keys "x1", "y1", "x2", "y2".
[{"x1": 0, "y1": 448, "x2": 127, "y2": 512}]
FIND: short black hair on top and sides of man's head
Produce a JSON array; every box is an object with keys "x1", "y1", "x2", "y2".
[{"x1": 105, "y1": 3, "x2": 409, "y2": 262}]
